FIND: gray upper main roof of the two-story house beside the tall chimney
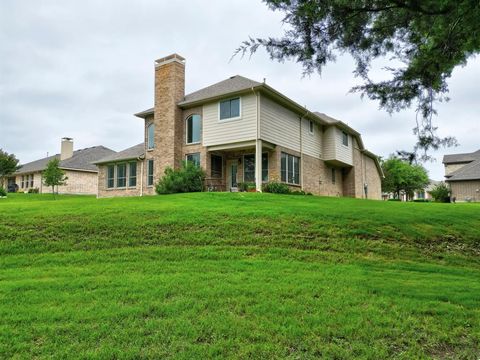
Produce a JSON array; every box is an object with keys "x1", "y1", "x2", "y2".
[{"x1": 135, "y1": 75, "x2": 262, "y2": 117}]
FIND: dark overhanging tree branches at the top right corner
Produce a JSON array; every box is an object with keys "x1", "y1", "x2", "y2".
[{"x1": 235, "y1": 0, "x2": 480, "y2": 160}]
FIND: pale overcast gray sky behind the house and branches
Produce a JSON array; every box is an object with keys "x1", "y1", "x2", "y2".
[{"x1": 0, "y1": 0, "x2": 480, "y2": 180}]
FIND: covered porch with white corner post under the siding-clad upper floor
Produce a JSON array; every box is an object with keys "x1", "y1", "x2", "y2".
[{"x1": 205, "y1": 140, "x2": 279, "y2": 192}]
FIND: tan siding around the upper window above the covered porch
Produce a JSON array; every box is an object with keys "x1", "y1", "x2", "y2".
[{"x1": 203, "y1": 94, "x2": 257, "y2": 146}]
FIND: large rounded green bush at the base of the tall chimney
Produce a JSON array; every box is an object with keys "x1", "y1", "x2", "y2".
[{"x1": 155, "y1": 161, "x2": 205, "y2": 194}]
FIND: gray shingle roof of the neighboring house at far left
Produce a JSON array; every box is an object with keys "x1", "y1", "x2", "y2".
[{"x1": 16, "y1": 146, "x2": 115, "y2": 174}]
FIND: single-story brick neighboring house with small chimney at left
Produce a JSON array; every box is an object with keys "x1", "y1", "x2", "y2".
[{"x1": 7, "y1": 138, "x2": 115, "y2": 195}]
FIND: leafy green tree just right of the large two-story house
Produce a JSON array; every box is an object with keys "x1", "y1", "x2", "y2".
[{"x1": 382, "y1": 156, "x2": 430, "y2": 199}]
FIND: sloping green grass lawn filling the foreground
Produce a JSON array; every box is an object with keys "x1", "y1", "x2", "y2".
[{"x1": 0, "y1": 193, "x2": 480, "y2": 359}]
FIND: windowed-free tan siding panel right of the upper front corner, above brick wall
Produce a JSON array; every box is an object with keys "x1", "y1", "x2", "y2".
[{"x1": 260, "y1": 96, "x2": 300, "y2": 151}]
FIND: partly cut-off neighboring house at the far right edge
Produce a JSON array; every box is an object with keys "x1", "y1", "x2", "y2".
[{"x1": 443, "y1": 150, "x2": 480, "y2": 201}]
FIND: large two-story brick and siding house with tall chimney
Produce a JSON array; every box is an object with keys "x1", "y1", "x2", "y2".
[{"x1": 96, "y1": 54, "x2": 382, "y2": 199}]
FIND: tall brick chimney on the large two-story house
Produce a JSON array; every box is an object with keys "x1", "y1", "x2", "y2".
[{"x1": 152, "y1": 54, "x2": 185, "y2": 176}]
